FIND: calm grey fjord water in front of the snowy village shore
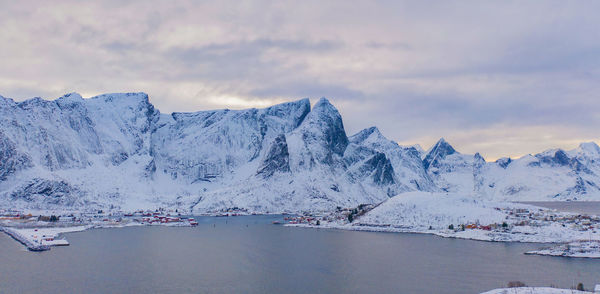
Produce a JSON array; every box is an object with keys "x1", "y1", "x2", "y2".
[{"x1": 0, "y1": 216, "x2": 600, "y2": 293}]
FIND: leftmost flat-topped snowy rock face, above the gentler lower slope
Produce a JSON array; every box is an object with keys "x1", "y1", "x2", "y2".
[{"x1": 0, "y1": 93, "x2": 154, "y2": 171}]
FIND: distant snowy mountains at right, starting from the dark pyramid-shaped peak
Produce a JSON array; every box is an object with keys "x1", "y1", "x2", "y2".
[{"x1": 423, "y1": 139, "x2": 600, "y2": 201}]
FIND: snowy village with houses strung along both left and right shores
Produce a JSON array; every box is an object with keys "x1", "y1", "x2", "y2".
[{"x1": 0, "y1": 204, "x2": 600, "y2": 257}]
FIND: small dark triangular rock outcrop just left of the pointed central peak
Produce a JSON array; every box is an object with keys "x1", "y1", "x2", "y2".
[{"x1": 256, "y1": 134, "x2": 290, "y2": 178}]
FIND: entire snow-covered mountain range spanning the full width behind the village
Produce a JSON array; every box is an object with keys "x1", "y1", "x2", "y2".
[{"x1": 0, "y1": 93, "x2": 600, "y2": 213}]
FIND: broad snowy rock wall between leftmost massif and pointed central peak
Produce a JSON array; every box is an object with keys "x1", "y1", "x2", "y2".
[{"x1": 152, "y1": 99, "x2": 310, "y2": 183}]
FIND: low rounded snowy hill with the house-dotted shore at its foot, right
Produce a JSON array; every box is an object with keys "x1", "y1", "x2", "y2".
[{"x1": 292, "y1": 192, "x2": 600, "y2": 257}]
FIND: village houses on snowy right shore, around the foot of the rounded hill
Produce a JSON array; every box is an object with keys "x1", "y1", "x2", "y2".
[{"x1": 285, "y1": 205, "x2": 600, "y2": 252}]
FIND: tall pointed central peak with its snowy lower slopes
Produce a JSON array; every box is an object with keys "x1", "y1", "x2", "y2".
[{"x1": 188, "y1": 99, "x2": 404, "y2": 212}]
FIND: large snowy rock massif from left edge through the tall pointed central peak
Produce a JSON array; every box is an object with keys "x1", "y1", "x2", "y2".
[{"x1": 0, "y1": 93, "x2": 408, "y2": 212}]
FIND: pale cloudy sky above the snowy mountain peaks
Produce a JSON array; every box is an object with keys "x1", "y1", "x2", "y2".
[{"x1": 0, "y1": 0, "x2": 600, "y2": 159}]
